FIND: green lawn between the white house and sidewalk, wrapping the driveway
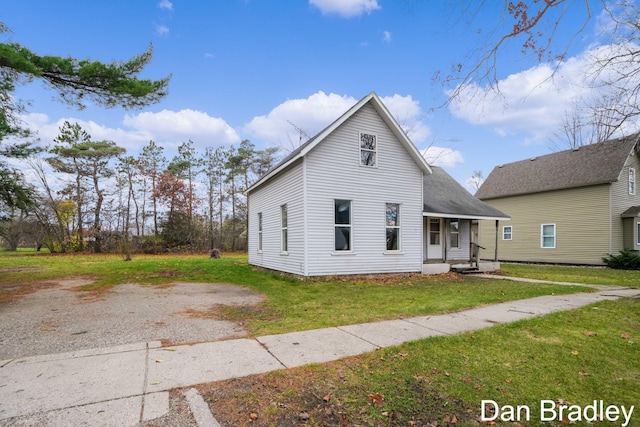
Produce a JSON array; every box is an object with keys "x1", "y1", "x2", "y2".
[{"x1": 0, "y1": 252, "x2": 600, "y2": 336}]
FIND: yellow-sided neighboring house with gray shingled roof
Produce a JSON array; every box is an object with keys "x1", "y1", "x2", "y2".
[{"x1": 475, "y1": 134, "x2": 640, "y2": 264}]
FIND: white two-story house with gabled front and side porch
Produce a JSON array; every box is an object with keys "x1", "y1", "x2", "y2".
[{"x1": 247, "y1": 92, "x2": 508, "y2": 276}]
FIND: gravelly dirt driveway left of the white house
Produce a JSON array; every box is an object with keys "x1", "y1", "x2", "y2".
[{"x1": 0, "y1": 278, "x2": 263, "y2": 360}]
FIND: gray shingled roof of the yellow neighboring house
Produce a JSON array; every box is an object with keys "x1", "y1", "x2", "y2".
[{"x1": 476, "y1": 134, "x2": 640, "y2": 200}]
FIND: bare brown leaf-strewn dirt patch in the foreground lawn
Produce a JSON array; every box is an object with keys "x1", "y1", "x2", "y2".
[{"x1": 197, "y1": 357, "x2": 480, "y2": 427}]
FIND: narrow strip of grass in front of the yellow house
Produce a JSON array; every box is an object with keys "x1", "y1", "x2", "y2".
[{"x1": 500, "y1": 264, "x2": 640, "y2": 288}]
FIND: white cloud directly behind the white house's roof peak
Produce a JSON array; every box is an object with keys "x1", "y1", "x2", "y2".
[{"x1": 244, "y1": 91, "x2": 430, "y2": 149}]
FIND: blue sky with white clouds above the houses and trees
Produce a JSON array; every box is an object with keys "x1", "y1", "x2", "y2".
[{"x1": 0, "y1": 0, "x2": 616, "y2": 190}]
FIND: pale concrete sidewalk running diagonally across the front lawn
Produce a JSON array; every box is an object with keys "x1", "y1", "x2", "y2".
[{"x1": 0, "y1": 288, "x2": 640, "y2": 427}]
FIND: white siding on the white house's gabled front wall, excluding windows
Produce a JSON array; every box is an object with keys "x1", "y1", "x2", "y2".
[{"x1": 305, "y1": 105, "x2": 422, "y2": 276}]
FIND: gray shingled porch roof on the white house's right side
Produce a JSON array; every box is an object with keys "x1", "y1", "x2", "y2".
[{"x1": 423, "y1": 166, "x2": 509, "y2": 219}]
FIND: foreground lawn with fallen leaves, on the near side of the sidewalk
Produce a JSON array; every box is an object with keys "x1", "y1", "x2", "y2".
[{"x1": 201, "y1": 299, "x2": 640, "y2": 427}]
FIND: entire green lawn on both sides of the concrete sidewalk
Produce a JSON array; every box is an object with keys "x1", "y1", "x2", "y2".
[{"x1": 5, "y1": 252, "x2": 640, "y2": 427}]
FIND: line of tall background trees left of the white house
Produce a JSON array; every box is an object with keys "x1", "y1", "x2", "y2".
[{"x1": 0, "y1": 122, "x2": 278, "y2": 257}]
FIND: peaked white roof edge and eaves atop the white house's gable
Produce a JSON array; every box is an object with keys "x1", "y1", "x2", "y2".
[{"x1": 247, "y1": 92, "x2": 431, "y2": 192}]
